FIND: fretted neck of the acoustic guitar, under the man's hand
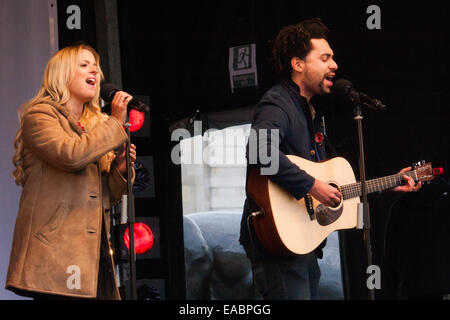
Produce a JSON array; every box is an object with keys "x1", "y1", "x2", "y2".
[{"x1": 342, "y1": 170, "x2": 418, "y2": 200}]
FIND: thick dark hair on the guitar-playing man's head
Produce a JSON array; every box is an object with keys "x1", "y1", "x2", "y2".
[{"x1": 272, "y1": 18, "x2": 329, "y2": 77}]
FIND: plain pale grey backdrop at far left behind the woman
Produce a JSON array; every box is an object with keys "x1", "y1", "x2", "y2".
[{"x1": 0, "y1": 0, "x2": 57, "y2": 299}]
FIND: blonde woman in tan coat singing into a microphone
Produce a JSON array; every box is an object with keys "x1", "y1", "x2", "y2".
[{"x1": 6, "y1": 44, "x2": 136, "y2": 299}]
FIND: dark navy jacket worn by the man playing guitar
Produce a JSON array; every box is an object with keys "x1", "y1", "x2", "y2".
[{"x1": 239, "y1": 80, "x2": 328, "y2": 258}]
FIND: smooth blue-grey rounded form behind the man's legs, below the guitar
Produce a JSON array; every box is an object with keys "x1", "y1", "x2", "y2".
[{"x1": 183, "y1": 212, "x2": 344, "y2": 300}]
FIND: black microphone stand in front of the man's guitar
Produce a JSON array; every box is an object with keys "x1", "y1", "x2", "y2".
[{"x1": 351, "y1": 96, "x2": 375, "y2": 300}]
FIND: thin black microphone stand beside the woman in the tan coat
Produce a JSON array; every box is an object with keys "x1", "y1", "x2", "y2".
[{"x1": 125, "y1": 120, "x2": 137, "y2": 300}]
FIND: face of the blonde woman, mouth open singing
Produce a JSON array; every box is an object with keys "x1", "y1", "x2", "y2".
[{"x1": 69, "y1": 49, "x2": 100, "y2": 104}]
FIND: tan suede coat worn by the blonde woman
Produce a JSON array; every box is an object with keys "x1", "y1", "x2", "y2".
[{"x1": 6, "y1": 102, "x2": 131, "y2": 298}]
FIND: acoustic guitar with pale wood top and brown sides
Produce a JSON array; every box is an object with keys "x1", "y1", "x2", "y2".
[{"x1": 247, "y1": 155, "x2": 434, "y2": 256}]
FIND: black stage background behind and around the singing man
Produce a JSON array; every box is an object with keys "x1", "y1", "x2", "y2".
[{"x1": 54, "y1": 0, "x2": 450, "y2": 299}]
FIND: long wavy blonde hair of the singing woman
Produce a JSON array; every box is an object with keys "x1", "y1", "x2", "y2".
[{"x1": 12, "y1": 43, "x2": 106, "y2": 185}]
